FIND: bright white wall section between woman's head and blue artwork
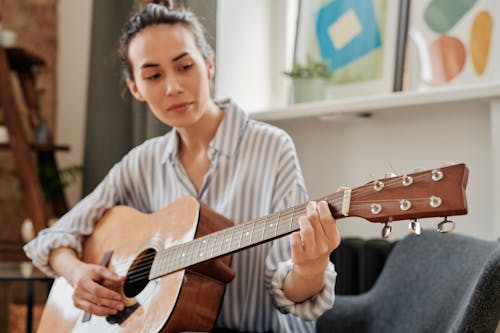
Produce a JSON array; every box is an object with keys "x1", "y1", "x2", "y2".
[{"x1": 215, "y1": 0, "x2": 293, "y2": 110}]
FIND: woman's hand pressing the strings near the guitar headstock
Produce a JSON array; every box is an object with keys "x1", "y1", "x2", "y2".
[{"x1": 285, "y1": 201, "x2": 340, "y2": 302}]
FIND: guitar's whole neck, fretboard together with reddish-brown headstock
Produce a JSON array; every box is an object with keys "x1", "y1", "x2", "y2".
[{"x1": 149, "y1": 164, "x2": 469, "y2": 279}]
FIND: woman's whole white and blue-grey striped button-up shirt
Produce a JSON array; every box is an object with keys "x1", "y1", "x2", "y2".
[{"x1": 24, "y1": 101, "x2": 336, "y2": 332}]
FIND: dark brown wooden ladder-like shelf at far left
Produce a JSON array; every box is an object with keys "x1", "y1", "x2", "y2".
[{"x1": 0, "y1": 47, "x2": 69, "y2": 259}]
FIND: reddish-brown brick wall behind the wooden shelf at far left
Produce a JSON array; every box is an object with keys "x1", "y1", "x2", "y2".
[{"x1": 0, "y1": 0, "x2": 57, "y2": 260}]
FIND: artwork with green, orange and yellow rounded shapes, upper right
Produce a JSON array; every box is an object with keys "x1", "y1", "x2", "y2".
[{"x1": 403, "y1": 0, "x2": 500, "y2": 90}]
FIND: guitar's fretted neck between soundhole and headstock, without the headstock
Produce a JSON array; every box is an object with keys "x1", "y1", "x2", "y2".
[{"x1": 149, "y1": 192, "x2": 344, "y2": 279}]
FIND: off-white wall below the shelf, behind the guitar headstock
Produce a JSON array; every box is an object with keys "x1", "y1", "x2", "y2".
[{"x1": 274, "y1": 103, "x2": 500, "y2": 239}]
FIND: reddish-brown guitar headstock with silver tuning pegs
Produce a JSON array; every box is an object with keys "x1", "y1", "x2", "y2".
[{"x1": 348, "y1": 164, "x2": 469, "y2": 222}]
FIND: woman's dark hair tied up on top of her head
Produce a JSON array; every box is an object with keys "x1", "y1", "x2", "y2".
[{"x1": 118, "y1": 0, "x2": 214, "y2": 80}]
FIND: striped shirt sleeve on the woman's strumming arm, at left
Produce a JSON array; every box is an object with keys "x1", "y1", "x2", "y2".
[{"x1": 24, "y1": 163, "x2": 122, "y2": 276}]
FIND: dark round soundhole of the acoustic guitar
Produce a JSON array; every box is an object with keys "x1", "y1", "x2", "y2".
[{"x1": 123, "y1": 249, "x2": 156, "y2": 297}]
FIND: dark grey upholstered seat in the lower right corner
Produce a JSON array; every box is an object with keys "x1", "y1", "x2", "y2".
[{"x1": 317, "y1": 231, "x2": 500, "y2": 333}]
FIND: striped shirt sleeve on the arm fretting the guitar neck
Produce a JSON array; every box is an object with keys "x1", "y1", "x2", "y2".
[{"x1": 264, "y1": 132, "x2": 337, "y2": 320}]
